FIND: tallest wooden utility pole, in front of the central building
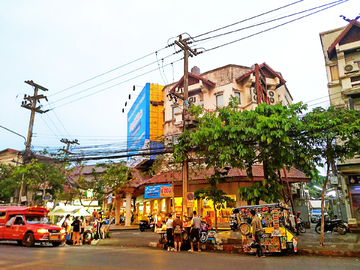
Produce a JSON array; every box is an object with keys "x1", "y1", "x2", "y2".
[{"x1": 173, "y1": 35, "x2": 197, "y2": 218}]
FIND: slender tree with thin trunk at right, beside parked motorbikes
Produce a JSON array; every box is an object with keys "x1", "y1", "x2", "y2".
[{"x1": 299, "y1": 107, "x2": 360, "y2": 246}]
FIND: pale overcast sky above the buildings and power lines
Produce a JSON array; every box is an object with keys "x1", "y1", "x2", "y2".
[{"x1": 0, "y1": 0, "x2": 360, "y2": 160}]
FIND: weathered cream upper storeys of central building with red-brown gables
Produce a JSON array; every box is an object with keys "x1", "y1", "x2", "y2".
[{"x1": 163, "y1": 63, "x2": 292, "y2": 141}]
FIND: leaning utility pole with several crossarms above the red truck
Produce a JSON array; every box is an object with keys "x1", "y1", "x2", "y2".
[{"x1": 18, "y1": 81, "x2": 49, "y2": 203}]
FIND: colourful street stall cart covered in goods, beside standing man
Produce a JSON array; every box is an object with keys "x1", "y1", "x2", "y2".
[{"x1": 233, "y1": 203, "x2": 297, "y2": 253}]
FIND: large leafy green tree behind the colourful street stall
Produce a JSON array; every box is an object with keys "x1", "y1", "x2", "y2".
[{"x1": 174, "y1": 100, "x2": 314, "y2": 209}]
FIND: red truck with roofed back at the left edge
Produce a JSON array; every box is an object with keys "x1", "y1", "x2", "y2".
[{"x1": 0, "y1": 206, "x2": 65, "y2": 247}]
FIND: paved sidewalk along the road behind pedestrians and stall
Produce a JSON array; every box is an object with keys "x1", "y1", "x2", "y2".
[{"x1": 103, "y1": 220, "x2": 360, "y2": 257}]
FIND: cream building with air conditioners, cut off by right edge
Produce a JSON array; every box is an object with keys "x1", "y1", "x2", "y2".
[{"x1": 320, "y1": 17, "x2": 360, "y2": 226}]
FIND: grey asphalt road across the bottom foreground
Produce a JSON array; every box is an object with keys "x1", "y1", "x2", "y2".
[{"x1": 0, "y1": 243, "x2": 360, "y2": 270}]
